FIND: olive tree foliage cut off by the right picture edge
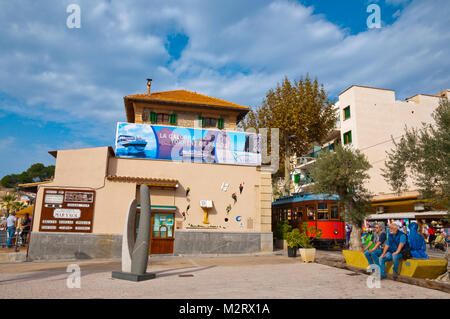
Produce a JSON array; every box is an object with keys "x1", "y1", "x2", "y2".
[{"x1": 383, "y1": 99, "x2": 450, "y2": 221}]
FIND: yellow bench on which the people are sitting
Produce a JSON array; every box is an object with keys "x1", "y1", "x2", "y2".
[{"x1": 342, "y1": 250, "x2": 447, "y2": 279}]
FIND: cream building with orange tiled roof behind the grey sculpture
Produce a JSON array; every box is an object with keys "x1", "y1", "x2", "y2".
[{"x1": 29, "y1": 83, "x2": 273, "y2": 260}]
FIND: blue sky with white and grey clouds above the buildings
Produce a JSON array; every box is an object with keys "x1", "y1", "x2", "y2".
[{"x1": 0, "y1": 0, "x2": 450, "y2": 177}]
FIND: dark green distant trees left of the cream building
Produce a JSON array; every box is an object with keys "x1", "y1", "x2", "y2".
[{"x1": 0, "y1": 163, "x2": 55, "y2": 187}]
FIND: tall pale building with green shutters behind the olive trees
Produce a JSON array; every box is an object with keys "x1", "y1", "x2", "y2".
[{"x1": 292, "y1": 85, "x2": 450, "y2": 228}]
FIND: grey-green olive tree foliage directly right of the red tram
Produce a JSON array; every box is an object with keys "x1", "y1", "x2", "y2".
[{"x1": 311, "y1": 144, "x2": 372, "y2": 227}]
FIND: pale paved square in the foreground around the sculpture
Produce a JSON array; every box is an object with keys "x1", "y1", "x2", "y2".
[{"x1": 0, "y1": 254, "x2": 450, "y2": 299}]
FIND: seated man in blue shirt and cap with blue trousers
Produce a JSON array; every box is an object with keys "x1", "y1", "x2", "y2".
[{"x1": 380, "y1": 223, "x2": 406, "y2": 280}]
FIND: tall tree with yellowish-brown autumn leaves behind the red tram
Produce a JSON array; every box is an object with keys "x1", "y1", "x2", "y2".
[{"x1": 240, "y1": 74, "x2": 336, "y2": 192}]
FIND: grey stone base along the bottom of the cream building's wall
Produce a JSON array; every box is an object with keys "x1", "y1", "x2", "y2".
[{"x1": 28, "y1": 231, "x2": 273, "y2": 261}]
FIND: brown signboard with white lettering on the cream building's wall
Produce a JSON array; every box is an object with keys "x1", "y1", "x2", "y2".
[{"x1": 39, "y1": 188, "x2": 95, "y2": 233}]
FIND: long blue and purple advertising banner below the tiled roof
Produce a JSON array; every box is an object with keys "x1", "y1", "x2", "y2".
[{"x1": 115, "y1": 122, "x2": 261, "y2": 166}]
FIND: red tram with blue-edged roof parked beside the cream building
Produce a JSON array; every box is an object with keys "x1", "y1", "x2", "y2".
[{"x1": 272, "y1": 194, "x2": 345, "y2": 248}]
